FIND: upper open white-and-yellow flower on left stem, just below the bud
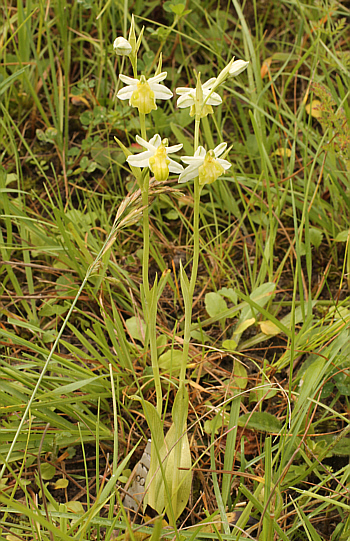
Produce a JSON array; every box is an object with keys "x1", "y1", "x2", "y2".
[{"x1": 117, "y1": 71, "x2": 173, "y2": 114}]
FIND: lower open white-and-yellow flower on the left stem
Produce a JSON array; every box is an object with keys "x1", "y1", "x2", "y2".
[{"x1": 127, "y1": 133, "x2": 183, "y2": 181}]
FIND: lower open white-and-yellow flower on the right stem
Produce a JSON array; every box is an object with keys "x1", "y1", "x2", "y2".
[{"x1": 179, "y1": 143, "x2": 231, "y2": 186}]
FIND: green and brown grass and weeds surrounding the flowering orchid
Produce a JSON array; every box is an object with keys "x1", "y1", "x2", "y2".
[{"x1": 0, "y1": 0, "x2": 350, "y2": 541}]
